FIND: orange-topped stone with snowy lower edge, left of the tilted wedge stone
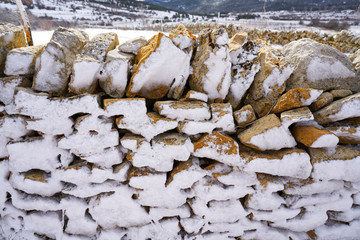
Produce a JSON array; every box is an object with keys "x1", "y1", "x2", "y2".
[{"x1": 193, "y1": 132, "x2": 245, "y2": 167}]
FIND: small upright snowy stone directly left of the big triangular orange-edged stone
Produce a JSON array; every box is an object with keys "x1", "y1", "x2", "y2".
[{"x1": 99, "y1": 49, "x2": 134, "y2": 98}]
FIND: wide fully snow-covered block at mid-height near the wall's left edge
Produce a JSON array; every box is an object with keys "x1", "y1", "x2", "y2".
[{"x1": 7, "y1": 136, "x2": 72, "y2": 172}]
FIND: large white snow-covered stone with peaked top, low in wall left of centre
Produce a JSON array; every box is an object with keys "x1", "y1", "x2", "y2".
[{"x1": 89, "y1": 185, "x2": 150, "y2": 229}]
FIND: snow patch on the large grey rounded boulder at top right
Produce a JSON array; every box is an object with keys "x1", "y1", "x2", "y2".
[{"x1": 306, "y1": 57, "x2": 355, "y2": 82}]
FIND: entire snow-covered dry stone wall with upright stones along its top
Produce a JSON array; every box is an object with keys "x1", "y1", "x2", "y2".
[{"x1": 0, "y1": 21, "x2": 360, "y2": 240}]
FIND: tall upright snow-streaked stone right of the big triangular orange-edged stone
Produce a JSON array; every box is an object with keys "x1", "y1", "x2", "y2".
[{"x1": 189, "y1": 28, "x2": 231, "y2": 101}]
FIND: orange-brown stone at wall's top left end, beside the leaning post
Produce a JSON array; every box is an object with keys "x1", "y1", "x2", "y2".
[{"x1": 0, "y1": 23, "x2": 27, "y2": 77}]
